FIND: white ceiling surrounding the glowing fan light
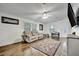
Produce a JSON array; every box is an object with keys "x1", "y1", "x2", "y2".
[{"x1": 0, "y1": 3, "x2": 67, "y2": 23}]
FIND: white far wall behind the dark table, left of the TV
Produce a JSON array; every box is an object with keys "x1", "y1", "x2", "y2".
[{"x1": 44, "y1": 18, "x2": 71, "y2": 37}]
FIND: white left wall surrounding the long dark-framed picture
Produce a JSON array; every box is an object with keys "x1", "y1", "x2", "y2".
[{"x1": 0, "y1": 12, "x2": 42, "y2": 46}]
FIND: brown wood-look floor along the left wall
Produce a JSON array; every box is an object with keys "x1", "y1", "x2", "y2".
[{"x1": 0, "y1": 37, "x2": 64, "y2": 56}]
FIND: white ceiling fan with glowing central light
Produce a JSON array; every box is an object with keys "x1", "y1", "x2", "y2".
[{"x1": 25, "y1": 3, "x2": 55, "y2": 19}]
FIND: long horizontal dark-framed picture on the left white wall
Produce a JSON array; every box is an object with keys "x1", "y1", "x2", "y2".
[{"x1": 1, "y1": 16, "x2": 19, "y2": 25}]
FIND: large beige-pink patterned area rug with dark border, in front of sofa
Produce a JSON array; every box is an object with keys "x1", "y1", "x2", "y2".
[{"x1": 31, "y1": 39, "x2": 60, "y2": 56}]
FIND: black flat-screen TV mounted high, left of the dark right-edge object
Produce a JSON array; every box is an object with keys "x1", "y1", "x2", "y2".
[{"x1": 68, "y1": 3, "x2": 76, "y2": 27}]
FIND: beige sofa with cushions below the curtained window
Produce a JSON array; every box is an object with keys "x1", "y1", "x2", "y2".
[{"x1": 23, "y1": 32, "x2": 43, "y2": 43}]
